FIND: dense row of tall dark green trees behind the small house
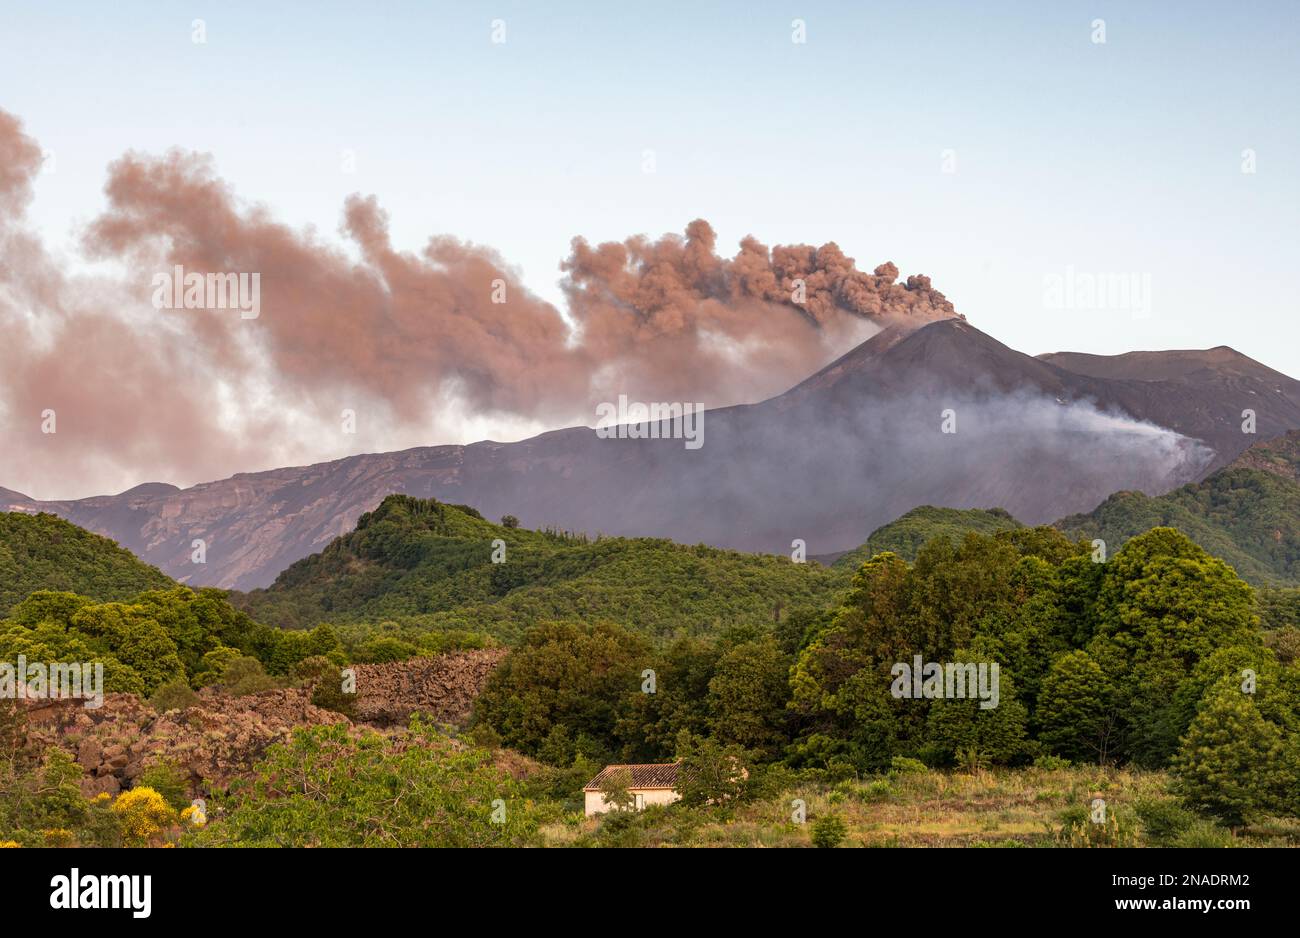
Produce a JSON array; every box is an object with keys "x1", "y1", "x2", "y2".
[{"x1": 476, "y1": 527, "x2": 1300, "y2": 824}]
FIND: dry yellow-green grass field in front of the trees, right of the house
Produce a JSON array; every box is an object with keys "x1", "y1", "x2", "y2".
[{"x1": 542, "y1": 767, "x2": 1300, "y2": 847}]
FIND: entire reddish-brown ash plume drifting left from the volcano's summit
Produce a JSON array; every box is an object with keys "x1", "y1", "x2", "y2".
[{"x1": 0, "y1": 112, "x2": 956, "y2": 498}]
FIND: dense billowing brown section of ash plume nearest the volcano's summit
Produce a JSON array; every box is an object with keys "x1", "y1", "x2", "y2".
[{"x1": 560, "y1": 220, "x2": 957, "y2": 405}]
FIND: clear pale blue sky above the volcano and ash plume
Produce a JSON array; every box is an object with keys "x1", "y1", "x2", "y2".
[{"x1": 0, "y1": 0, "x2": 1300, "y2": 368}]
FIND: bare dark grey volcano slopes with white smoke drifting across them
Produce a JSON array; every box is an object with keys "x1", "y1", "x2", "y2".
[{"x1": 5, "y1": 320, "x2": 1300, "y2": 589}]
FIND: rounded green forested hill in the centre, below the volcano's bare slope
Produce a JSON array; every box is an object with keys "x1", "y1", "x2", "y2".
[{"x1": 233, "y1": 495, "x2": 848, "y2": 640}]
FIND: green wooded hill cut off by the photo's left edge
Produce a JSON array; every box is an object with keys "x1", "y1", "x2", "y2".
[{"x1": 0, "y1": 512, "x2": 176, "y2": 618}]
